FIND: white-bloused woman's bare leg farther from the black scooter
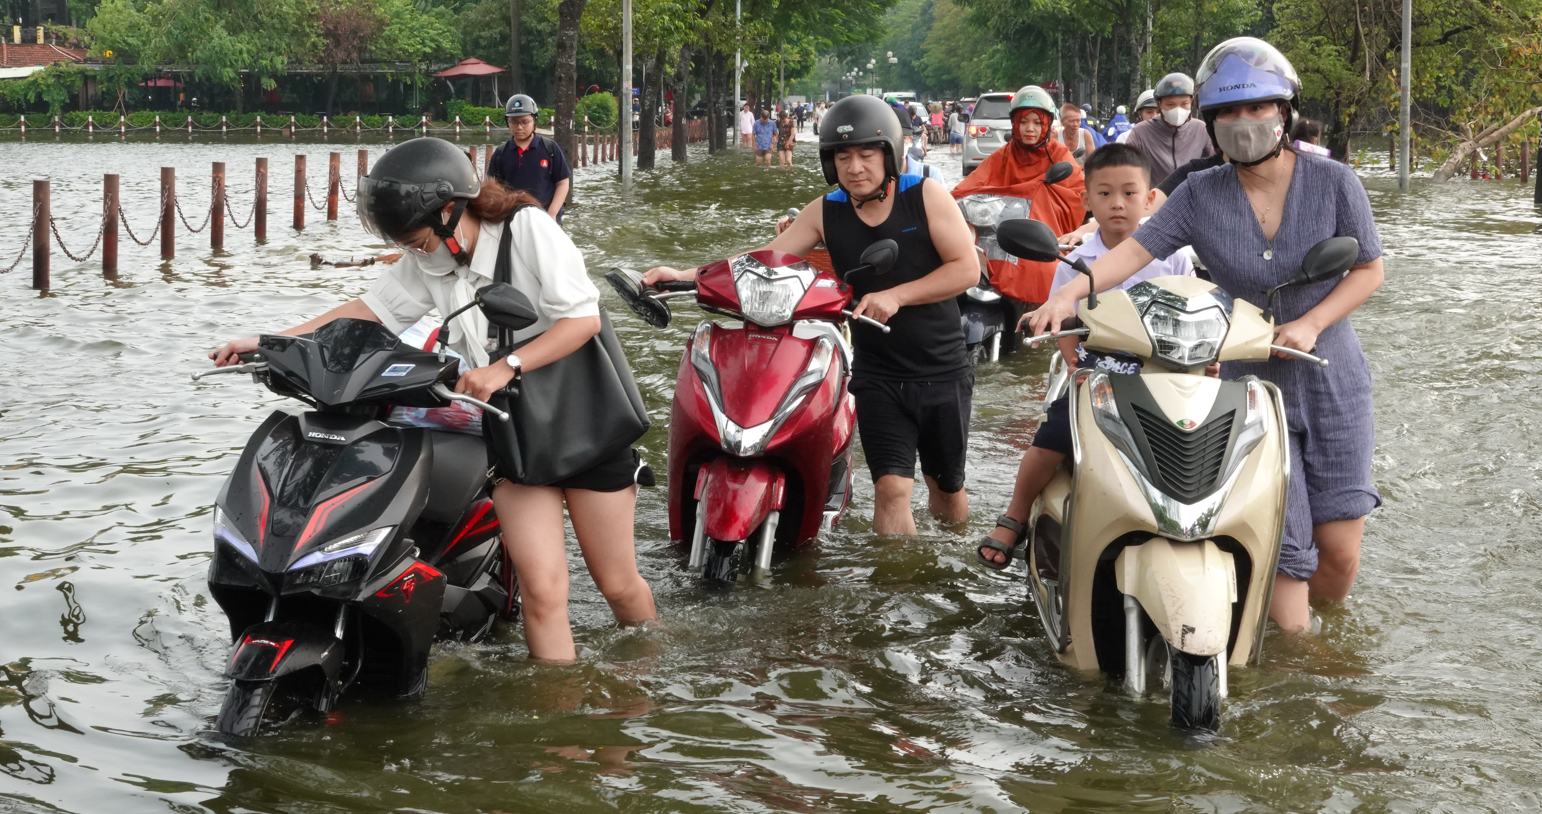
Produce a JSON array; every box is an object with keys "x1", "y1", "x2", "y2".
[{"x1": 564, "y1": 486, "x2": 658, "y2": 624}]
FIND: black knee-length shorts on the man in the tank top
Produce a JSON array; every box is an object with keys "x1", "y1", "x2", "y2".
[{"x1": 851, "y1": 373, "x2": 975, "y2": 493}]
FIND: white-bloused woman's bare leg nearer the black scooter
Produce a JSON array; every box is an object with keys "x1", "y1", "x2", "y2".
[{"x1": 492, "y1": 483, "x2": 578, "y2": 661}]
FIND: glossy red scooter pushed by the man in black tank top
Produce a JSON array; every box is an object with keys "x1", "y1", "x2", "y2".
[{"x1": 606, "y1": 241, "x2": 899, "y2": 581}]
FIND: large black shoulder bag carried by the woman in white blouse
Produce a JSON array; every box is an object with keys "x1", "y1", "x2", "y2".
[{"x1": 483, "y1": 204, "x2": 648, "y2": 486}]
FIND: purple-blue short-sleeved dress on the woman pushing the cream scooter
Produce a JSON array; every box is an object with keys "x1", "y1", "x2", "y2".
[{"x1": 1135, "y1": 154, "x2": 1382, "y2": 580}]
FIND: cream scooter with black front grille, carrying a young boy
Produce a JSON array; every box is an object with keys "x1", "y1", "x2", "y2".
[{"x1": 998, "y1": 220, "x2": 1359, "y2": 731}]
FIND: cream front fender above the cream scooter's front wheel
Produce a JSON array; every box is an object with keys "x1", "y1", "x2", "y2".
[{"x1": 1113, "y1": 537, "x2": 1237, "y2": 657}]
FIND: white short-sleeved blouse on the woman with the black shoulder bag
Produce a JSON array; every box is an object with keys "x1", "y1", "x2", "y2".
[{"x1": 359, "y1": 207, "x2": 600, "y2": 367}]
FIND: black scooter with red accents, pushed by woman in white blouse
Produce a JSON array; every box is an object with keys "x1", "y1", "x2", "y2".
[{"x1": 193, "y1": 284, "x2": 537, "y2": 737}]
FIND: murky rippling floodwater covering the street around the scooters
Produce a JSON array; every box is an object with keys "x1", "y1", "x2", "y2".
[{"x1": 0, "y1": 134, "x2": 1542, "y2": 812}]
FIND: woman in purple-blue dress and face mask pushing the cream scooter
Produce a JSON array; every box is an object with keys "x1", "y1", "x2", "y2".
[{"x1": 1030, "y1": 37, "x2": 1383, "y2": 632}]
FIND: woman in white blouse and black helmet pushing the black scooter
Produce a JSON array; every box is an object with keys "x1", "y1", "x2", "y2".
[{"x1": 210, "y1": 139, "x2": 655, "y2": 661}]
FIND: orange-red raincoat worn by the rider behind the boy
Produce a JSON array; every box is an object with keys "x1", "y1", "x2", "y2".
[{"x1": 953, "y1": 122, "x2": 1086, "y2": 304}]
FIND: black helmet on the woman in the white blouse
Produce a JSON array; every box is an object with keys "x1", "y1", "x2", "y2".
[{"x1": 358, "y1": 139, "x2": 481, "y2": 264}]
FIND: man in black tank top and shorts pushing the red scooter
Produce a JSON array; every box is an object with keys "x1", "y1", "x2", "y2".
[{"x1": 645, "y1": 96, "x2": 979, "y2": 535}]
